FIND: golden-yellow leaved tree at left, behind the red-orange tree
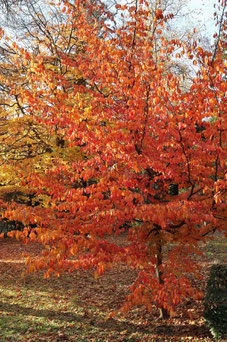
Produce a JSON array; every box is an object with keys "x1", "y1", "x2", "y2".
[{"x1": 0, "y1": 2, "x2": 88, "y2": 232}]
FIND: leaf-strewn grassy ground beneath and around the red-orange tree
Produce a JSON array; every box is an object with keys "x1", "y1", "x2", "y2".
[{"x1": 0, "y1": 234, "x2": 227, "y2": 342}]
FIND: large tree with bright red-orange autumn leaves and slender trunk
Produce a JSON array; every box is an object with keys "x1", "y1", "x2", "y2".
[{"x1": 0, "y1": 0, "x2": 226, "y2": 317}]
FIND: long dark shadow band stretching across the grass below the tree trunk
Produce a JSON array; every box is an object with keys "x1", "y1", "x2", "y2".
[{"x1": 0, "y1": 301, "x2": 213, "y2": 338}]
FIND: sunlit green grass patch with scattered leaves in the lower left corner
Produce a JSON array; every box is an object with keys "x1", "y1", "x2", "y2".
[{"x1": 0, "y1": 276, "x2": 153, "y2": 342}]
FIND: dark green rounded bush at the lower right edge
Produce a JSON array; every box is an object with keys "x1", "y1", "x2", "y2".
[{"x1": 204, "y1": 265, "x2": 227, "y2": 339}]
